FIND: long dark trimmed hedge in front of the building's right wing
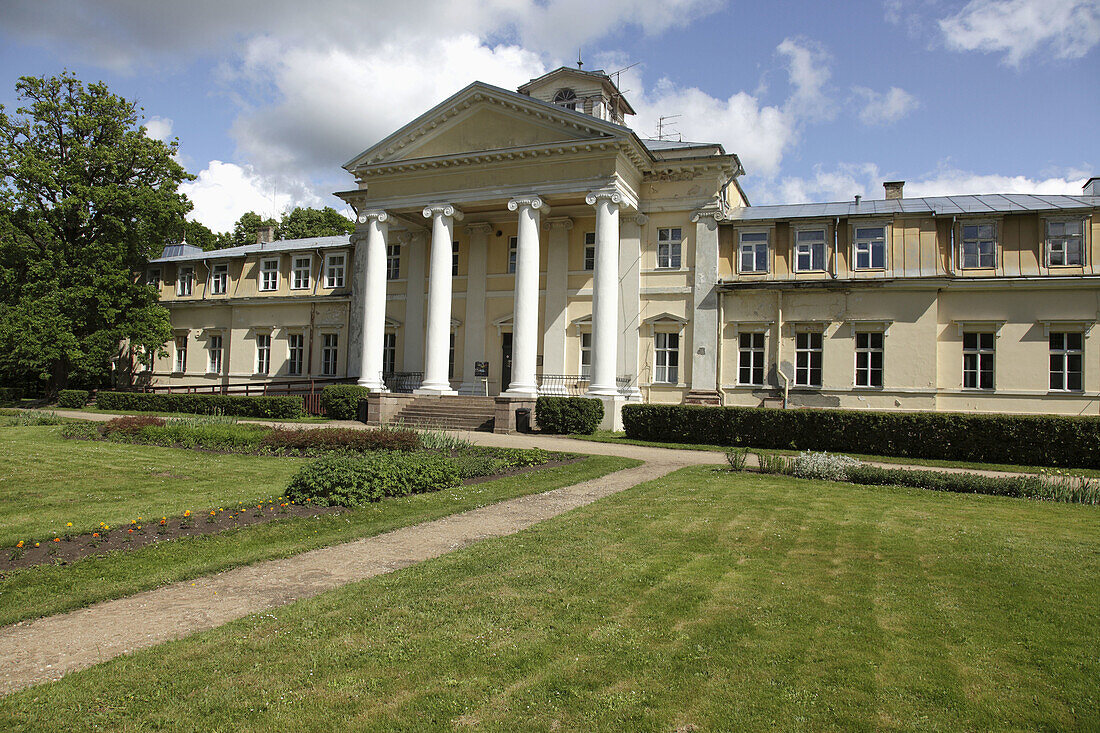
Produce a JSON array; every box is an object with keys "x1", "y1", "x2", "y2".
[{"x1": 623, "y1": 405, "x2": 1100, "y2": 469}]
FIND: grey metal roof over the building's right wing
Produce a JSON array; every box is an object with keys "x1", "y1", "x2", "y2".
[{"x1": 725, "y1": 194, "x2": 1100, "y2": 221}]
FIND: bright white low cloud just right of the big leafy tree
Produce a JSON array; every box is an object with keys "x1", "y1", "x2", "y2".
[{"x1": 179, "y1": 161, "x2": 322, "y2": 231}]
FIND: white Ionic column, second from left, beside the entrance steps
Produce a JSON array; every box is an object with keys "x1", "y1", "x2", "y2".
[{"x1": 416, "y1": 204, "x2": 462, "y2": 394}]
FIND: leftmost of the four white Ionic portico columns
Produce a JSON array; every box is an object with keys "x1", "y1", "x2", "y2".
[{"x1": 356, "y1": 209, "x2": 389, "y2": 392}]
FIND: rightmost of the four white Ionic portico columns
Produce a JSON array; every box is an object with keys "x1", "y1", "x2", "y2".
[{"x1": 584, "y1": 190, "x2": 623, "y2": 396}]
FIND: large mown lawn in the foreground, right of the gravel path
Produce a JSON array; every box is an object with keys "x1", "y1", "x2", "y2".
[{"x1": 0, "y1": 467, "x2": 1100, "y2": 732}]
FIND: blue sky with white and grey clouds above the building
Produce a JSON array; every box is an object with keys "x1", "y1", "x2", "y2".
[{"x1": 0, "y1": 0, "x2": 1100, "y2": 231}]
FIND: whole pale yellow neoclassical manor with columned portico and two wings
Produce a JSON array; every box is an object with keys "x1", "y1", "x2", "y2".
[{"x1": 146, "y1": 68, "x2": 1100, "y2": 427}]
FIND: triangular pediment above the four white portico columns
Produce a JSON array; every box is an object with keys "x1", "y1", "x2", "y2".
[{"x1": 344, "y1": 83, "x2": 631, "y2": 172}]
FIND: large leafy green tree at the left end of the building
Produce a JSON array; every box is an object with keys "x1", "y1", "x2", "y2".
[{"x1": 0, "y1": 73, "x2": 191, "y2": 392}]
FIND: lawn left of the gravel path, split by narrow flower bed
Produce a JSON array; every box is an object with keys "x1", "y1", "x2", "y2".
[{"x1": 0, "y1": 428, "x2": 638, "y2": 626}]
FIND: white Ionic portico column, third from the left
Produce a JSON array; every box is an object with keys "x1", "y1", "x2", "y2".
[{"x1": 507, "y1": 196, "x2": 550, "y2": 396}]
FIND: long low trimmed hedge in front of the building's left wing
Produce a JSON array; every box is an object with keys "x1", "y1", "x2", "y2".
[{"x1": 96, "y1": 392, "x2": 306, "y2": 419}]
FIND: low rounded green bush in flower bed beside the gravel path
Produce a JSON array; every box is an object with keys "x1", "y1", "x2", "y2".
[{"x1": 286, "y1": 452, "x2": 460, "y2": 506}]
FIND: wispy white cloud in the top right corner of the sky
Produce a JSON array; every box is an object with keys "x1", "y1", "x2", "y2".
[{"x1": 939, "y1": 0, "x2": 1100, "y2": 66}]
